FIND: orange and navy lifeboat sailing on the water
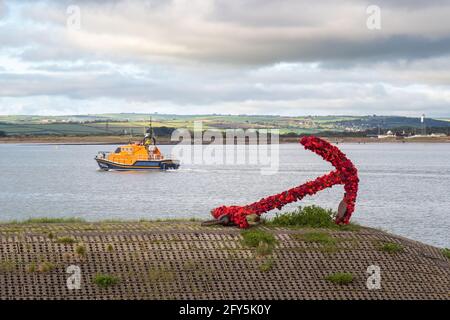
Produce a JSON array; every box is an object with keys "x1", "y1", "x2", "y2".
[{"x1": 95, "y1": 125, "x2": 180, "y2": 171}]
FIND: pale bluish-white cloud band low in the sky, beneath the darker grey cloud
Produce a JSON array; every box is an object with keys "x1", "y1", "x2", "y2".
[{"x1": 0, "y1": 64, "x2": 450, "y2": 107}]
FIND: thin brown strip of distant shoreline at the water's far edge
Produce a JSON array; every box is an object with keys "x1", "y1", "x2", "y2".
[{"x1": 0, "y1": 136, "x2": 450, "y2": 145}]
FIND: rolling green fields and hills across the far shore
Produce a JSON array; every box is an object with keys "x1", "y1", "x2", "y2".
[{"x1": 0, "y1": 113, "x2": 450, "y2": 136}]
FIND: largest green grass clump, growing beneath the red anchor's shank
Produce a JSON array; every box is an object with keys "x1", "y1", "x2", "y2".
[{"x1": 266, "y1": 205, "x2": 360, "y2": 231}]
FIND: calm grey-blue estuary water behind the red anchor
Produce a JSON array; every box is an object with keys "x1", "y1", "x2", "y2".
[{"x1": 0, "y1": 143, "x2": 450, "y2": 247}]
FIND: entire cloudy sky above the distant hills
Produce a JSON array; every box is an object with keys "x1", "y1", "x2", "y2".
[{"x1": 0, "y1": 0, "x2": 450, "y2": 117}]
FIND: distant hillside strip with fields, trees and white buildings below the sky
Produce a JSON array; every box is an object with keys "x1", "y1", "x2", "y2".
[{"x1": 0, "y1": 113, "x2": 450, "y2": 140}]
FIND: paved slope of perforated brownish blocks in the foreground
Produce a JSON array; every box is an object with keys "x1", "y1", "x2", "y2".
[{"x1": 0, "y1": 222, "x2": 450, "y2": 299}]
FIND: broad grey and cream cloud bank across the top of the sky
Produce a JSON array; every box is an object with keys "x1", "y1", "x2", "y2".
[{"x1": 3, "y1": 0, "x2": 450, "y2": 65}]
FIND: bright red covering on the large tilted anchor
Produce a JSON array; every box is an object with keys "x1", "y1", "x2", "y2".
[{"x1": 211, "y1": 136, "x2": 359, "y2": 228}]
